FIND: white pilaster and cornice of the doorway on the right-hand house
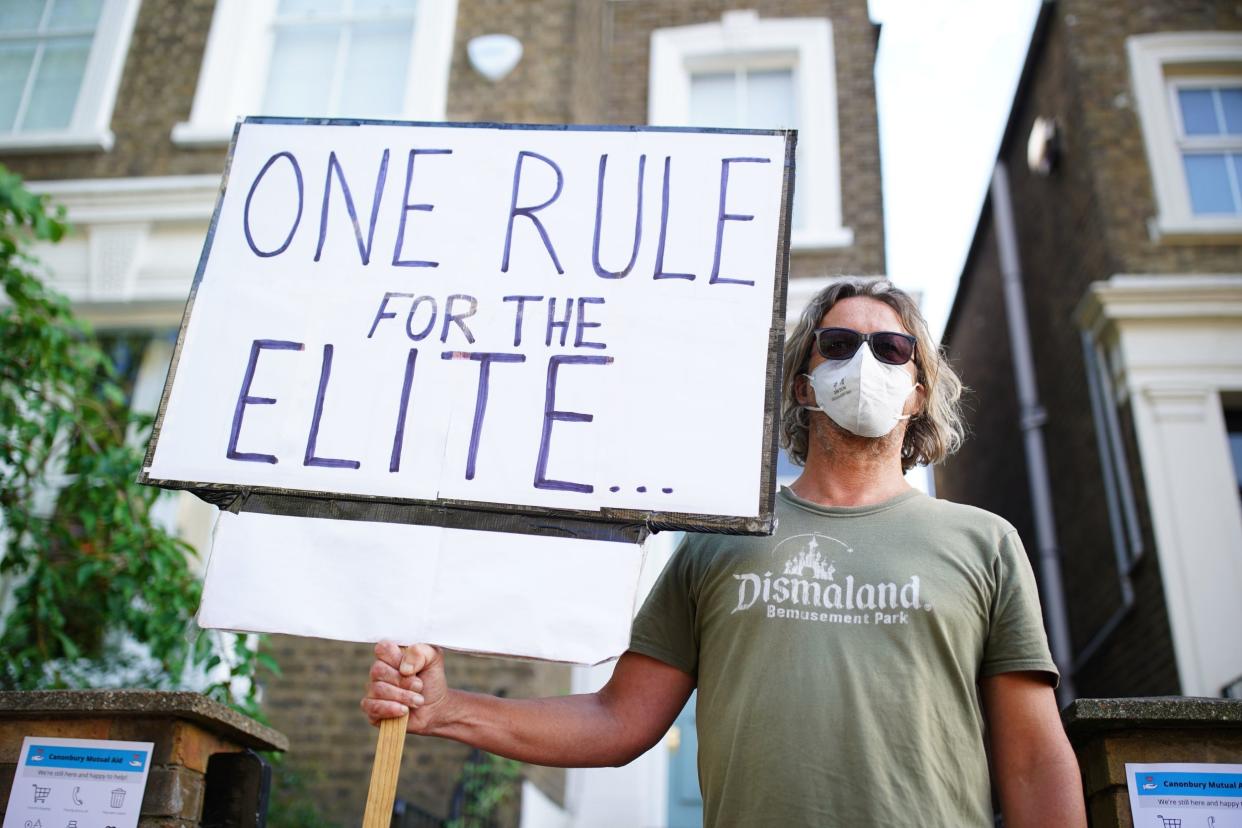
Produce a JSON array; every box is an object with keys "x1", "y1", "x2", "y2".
[{"x1": 1078, "y1": 273, "x2": 1242, "y2": 696}]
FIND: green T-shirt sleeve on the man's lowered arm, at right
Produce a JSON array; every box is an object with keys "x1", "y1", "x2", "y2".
[{"x1": 980, "y1": 530, "x2": 1061, "y2": 685}]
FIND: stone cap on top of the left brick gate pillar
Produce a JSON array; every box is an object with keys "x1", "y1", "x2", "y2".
[{"x1": 0, "y1": 690, "x2": 289, "y2": 751}]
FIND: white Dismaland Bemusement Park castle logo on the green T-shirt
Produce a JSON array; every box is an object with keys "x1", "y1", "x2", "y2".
[{"x1": 733, "y1": 533, "x2": 932, "y2": 626}]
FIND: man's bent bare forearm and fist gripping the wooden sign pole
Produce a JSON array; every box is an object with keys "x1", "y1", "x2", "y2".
[{"x1": 361, "y1": 642, "x2": 694, "y2": 767}]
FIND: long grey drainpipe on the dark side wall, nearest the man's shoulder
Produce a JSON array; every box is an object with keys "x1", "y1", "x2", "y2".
[{"x1": 991, "y1": 161, "x2": 1076, "y2": 708}]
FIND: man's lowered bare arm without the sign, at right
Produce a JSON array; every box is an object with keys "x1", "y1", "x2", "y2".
[{"x1": 979, "y1": 673, "x2": 1087, "y2": 828}]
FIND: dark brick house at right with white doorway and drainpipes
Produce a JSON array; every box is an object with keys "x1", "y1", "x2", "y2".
[{"x1": 935, "y1": 0, "x2": 1242, "y2": 696}]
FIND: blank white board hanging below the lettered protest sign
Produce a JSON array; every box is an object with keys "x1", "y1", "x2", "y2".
[{"x1": 199, "y1": 511, "x2": 643, "y2": 664}]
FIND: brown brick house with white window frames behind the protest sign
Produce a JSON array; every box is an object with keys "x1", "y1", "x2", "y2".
[{"x1": 0, "y1": 0, "x2": 884, "y2": 824}]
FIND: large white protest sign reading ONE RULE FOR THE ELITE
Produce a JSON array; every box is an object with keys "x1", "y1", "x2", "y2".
[{"x1": 142, "y1": 118, "x2": 794, "y2": 540}]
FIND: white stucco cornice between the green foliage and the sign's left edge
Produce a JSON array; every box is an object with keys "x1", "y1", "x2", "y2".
[{"x1": 27, "y1": 175, "x2": 220, "y2": 328}]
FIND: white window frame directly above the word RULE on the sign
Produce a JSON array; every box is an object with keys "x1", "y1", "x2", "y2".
[{"x1": 647, "y1": 11, "x2": 853, "y2": 250}]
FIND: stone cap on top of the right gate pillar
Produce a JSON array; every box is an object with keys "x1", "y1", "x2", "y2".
[{"x1": 1061, "y1": 695, "x2": 1242, "y2": 732}]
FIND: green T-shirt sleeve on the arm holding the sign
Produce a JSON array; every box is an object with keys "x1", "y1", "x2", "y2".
[{"x1": 630, "y1": 535, "x2": 698, "y2": 675}]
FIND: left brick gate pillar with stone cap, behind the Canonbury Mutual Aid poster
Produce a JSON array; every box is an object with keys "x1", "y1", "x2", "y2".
[{"x1": 0, "y1": 690, "x2": 289, "y2": 828}]
